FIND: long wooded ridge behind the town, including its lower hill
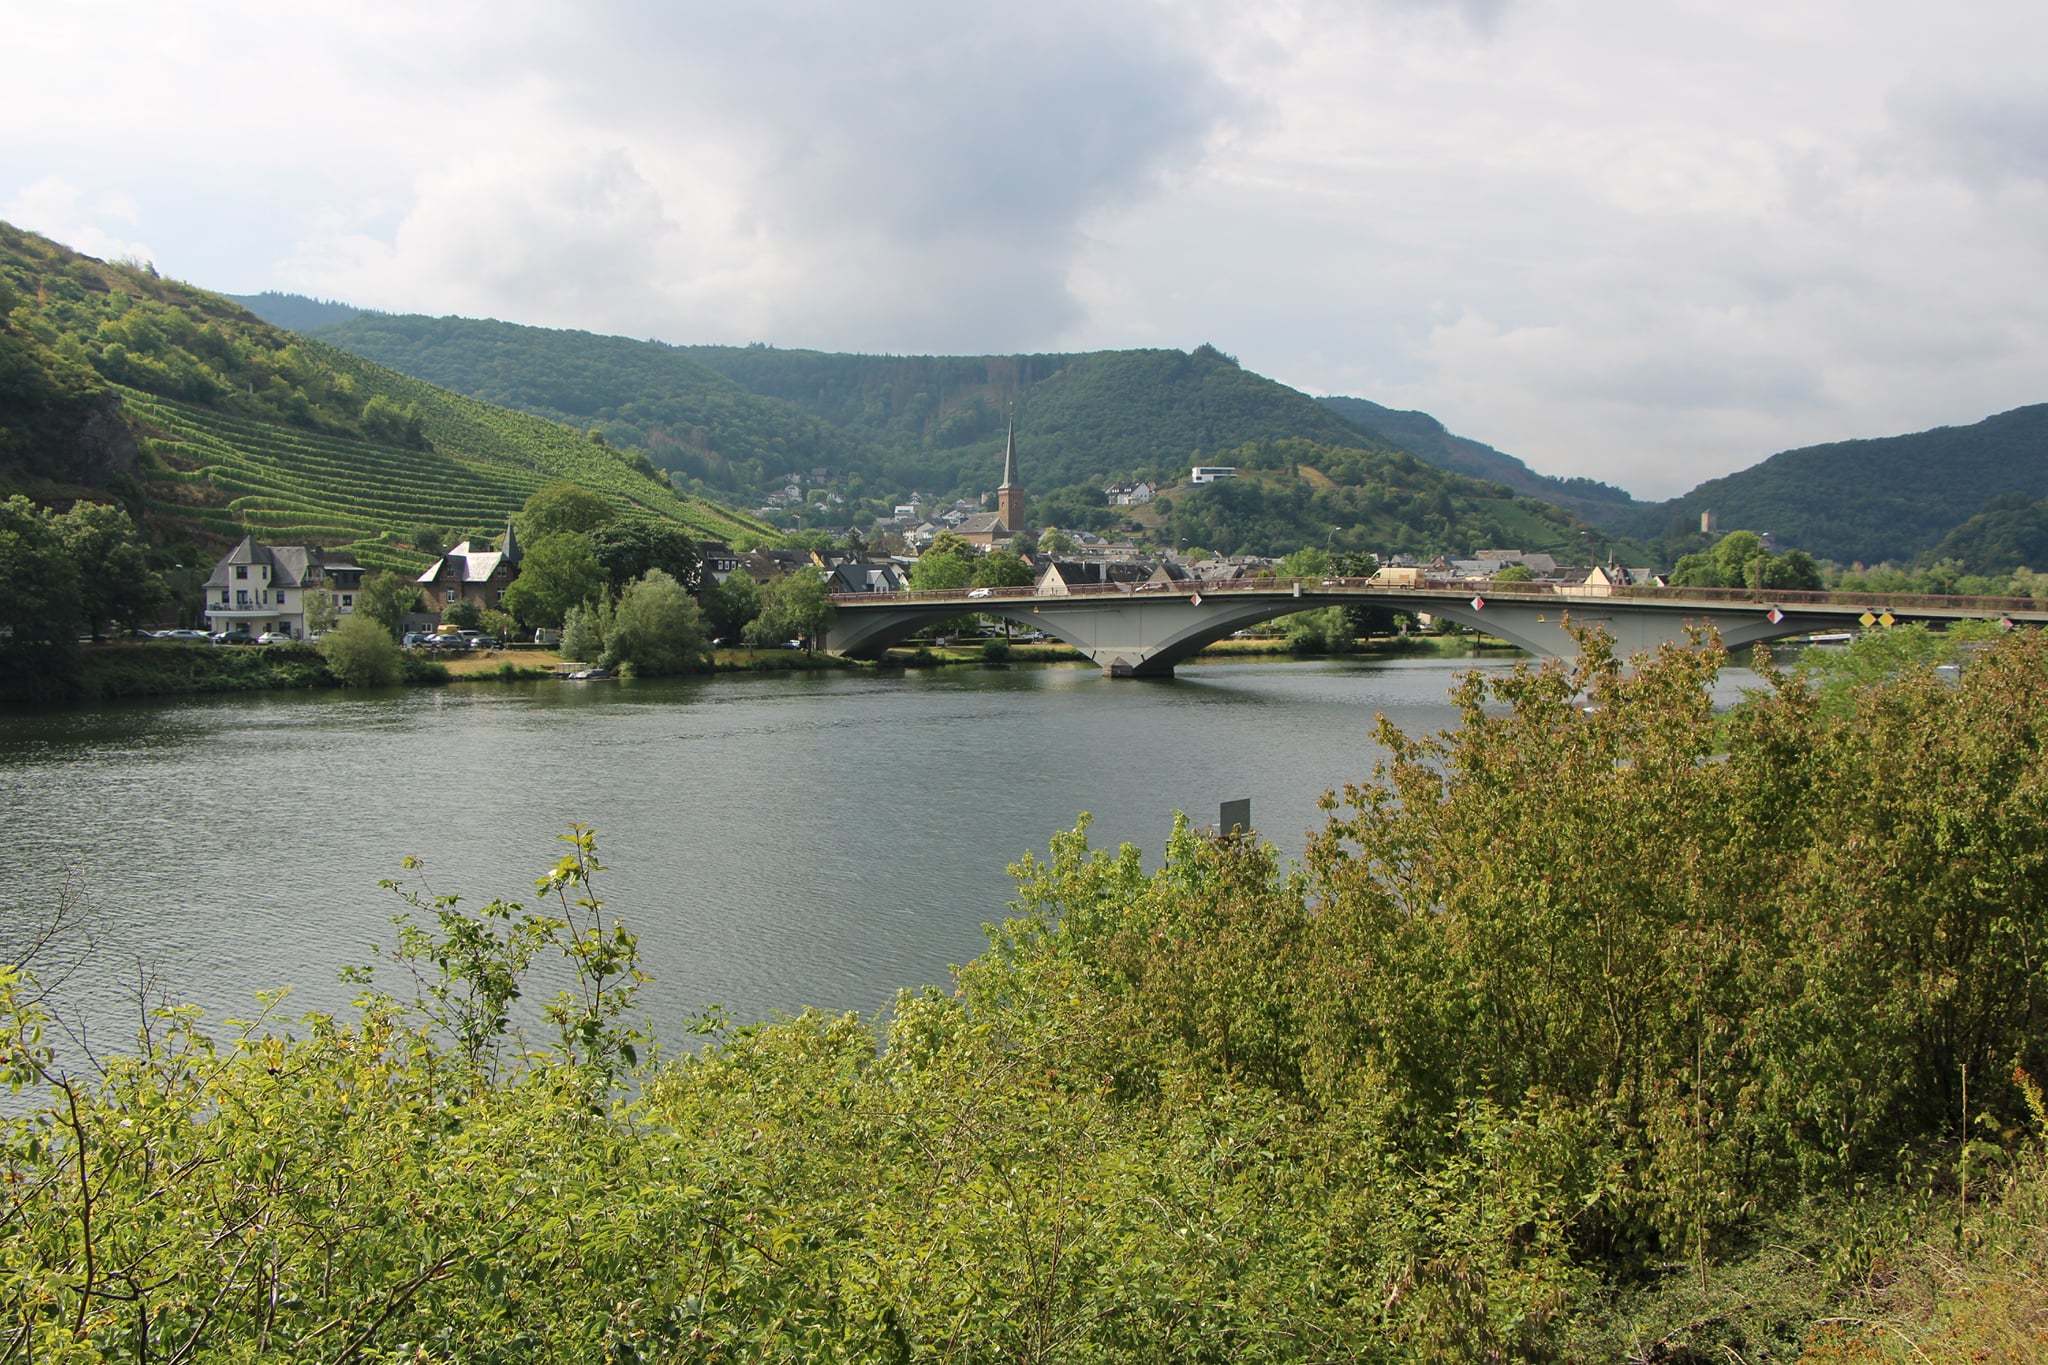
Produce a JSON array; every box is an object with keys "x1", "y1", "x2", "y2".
[{"x1": 268, "y1": 296, "x2": 1626, "y2": 557}]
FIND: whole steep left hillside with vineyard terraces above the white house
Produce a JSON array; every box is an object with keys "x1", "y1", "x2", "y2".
[{"x1": 0, "y1": 223, "x2": 766, "y2": 567}]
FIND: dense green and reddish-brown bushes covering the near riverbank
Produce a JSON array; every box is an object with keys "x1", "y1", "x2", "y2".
[{"x1": 0, "y1": 632, "x2": 2048, "y2": 1361}]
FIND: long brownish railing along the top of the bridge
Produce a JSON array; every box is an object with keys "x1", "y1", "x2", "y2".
[{"x1": 831, "y1": 577, "x2": 2048, "y2": 614}]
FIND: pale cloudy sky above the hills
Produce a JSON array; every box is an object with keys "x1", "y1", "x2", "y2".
[{"x1": 0, "y1": 0, "x2": 2048, "y2": 497}]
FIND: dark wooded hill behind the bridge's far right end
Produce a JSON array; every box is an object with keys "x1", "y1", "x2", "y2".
[{"x1": 1634, "y1": 403, "x2": 2048, "y2": 563}]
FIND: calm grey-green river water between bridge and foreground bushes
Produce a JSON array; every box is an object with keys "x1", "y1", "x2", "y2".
[{"x1": 0, "y1": 659, "x2": 1739, "y2": 1046}]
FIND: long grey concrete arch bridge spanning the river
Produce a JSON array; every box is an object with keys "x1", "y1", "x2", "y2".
[{"x1": 825, "y1": 579, "x2": 2048, "y2": 677}]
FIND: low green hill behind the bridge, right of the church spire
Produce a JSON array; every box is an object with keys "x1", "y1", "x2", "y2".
[{"x1": 1163, "y1": 440, "x2": 1606, "y2": 561}]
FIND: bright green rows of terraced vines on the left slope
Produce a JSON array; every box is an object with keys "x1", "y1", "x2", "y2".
[{"x1": 121, "y1": 389, "x2": 770, "y2": 569}]
